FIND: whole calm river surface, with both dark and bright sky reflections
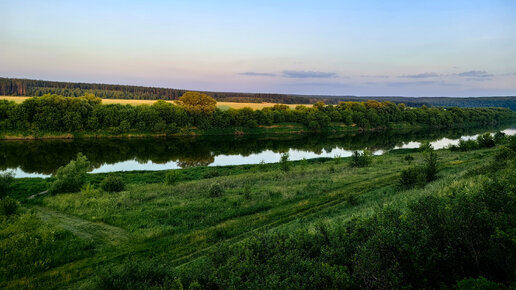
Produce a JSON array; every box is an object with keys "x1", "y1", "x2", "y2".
[{"x1": 0, "y1": 126, "x2": 516, "y2": 177}]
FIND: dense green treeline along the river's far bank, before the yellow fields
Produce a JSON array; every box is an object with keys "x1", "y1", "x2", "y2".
[{"x1": 0, "y1": 95, "x2": 515, "y2": 136}]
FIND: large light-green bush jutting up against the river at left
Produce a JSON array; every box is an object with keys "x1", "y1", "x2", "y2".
[{"x1": 49, "y1": 153, "x2": 90, "y2": 194}]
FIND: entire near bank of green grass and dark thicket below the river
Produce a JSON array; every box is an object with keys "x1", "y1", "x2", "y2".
[{"x1": 0, "y1": 136, "x2": 516, "y2": 289}]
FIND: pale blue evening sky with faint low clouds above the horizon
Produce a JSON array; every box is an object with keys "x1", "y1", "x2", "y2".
[{"x1": 0, "y1": 0, "x2": 516, "y2": 96}]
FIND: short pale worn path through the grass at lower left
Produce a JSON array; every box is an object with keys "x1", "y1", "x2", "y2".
[{"x1": 30, "y1": 206, "x2": 130, "y2": 245}]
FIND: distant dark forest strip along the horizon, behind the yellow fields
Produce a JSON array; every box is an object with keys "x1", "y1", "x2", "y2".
[{"x1": 0, "y1": 78, "x2": 516, "y2": 111}]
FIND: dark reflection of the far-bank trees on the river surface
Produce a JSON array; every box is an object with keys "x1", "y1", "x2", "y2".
[{"x1": 0, "y1": 126, "x2": 507, "y2": 174}]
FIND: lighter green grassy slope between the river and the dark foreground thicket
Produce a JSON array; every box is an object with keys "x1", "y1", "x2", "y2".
[{"x1": 0, "y1": 149, "x2": 512, "y2": 289}]
